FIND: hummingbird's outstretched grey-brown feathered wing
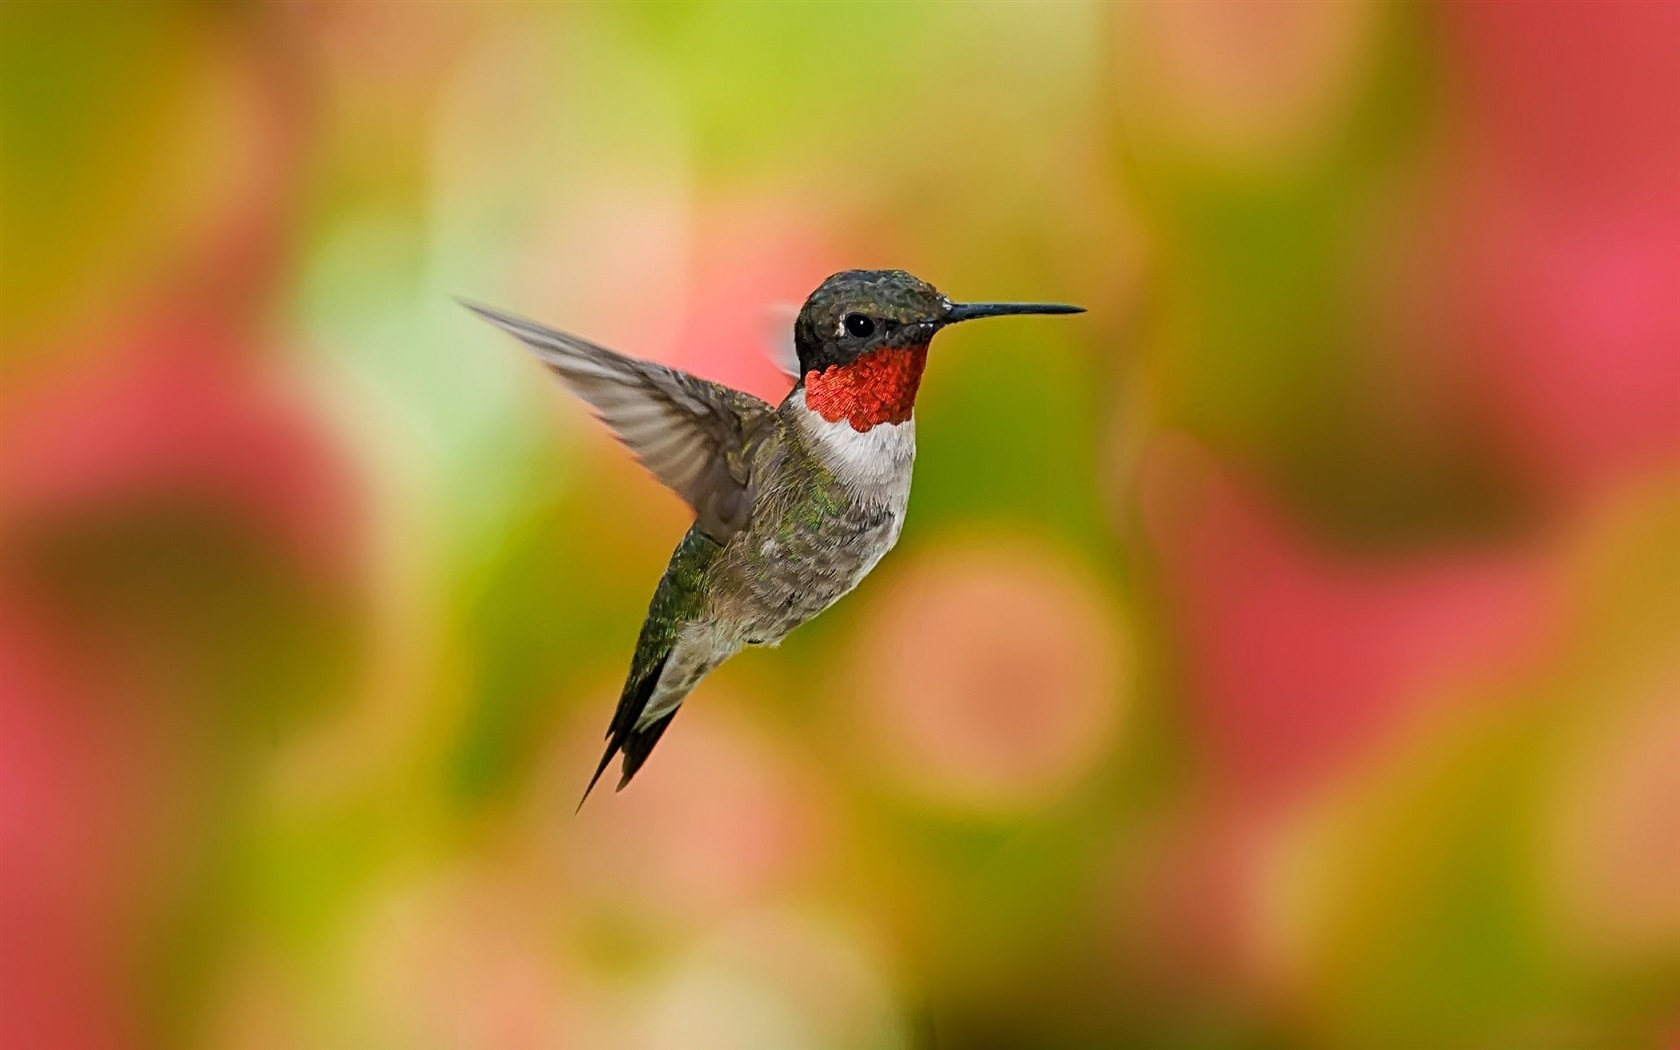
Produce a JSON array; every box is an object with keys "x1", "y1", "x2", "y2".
[{"x1": 462, "y1": 301, "x2": 776, "y2": 543}]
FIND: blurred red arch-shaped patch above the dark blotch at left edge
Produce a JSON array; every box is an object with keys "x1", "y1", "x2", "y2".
[{"x1": 0, "y1": 316, "x2": 353, "y2": 578}]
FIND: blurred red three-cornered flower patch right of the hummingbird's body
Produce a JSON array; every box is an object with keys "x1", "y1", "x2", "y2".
[{"x1": 1142, "y1": 438, "x2": 1557, "y2": 805}]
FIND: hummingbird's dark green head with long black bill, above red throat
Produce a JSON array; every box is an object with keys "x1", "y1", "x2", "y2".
[{"x1": 793, "y1": 270, "x2": 1084, "y2": 375}]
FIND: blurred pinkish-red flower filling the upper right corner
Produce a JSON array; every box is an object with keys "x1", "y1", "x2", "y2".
[{"x1": 1438, "y1": 2, "x2": 1680, "y2": 497}]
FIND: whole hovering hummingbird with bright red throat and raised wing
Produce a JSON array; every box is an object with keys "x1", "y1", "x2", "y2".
[{"x1": 464, "y1": 270, "x2": 1084, "y2": 808}]
